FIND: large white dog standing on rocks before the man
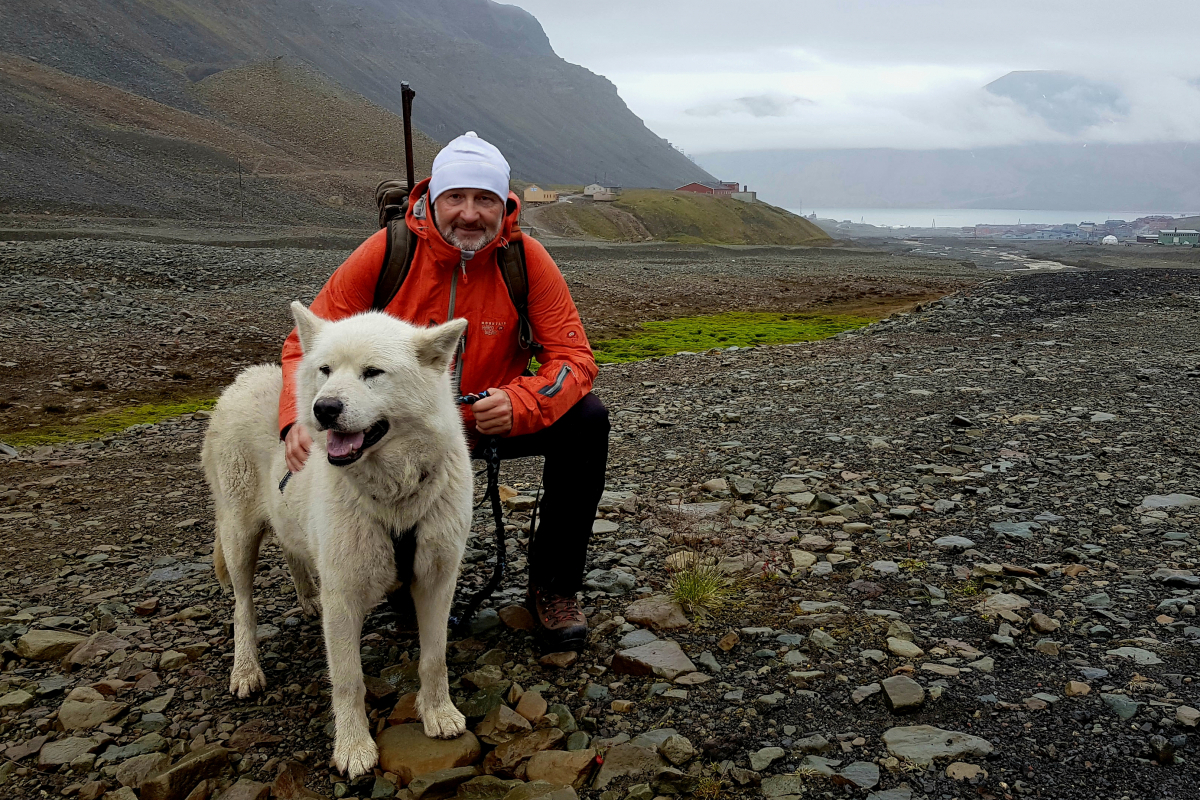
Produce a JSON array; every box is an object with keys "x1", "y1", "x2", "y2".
[{"x1": 202, "y1": 302, "x2": 473, "y2": 777}]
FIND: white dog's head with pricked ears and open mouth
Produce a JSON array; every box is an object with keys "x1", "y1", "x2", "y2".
[{"x1": 292, "y1": 302, "x2": 467, "y2": 467}]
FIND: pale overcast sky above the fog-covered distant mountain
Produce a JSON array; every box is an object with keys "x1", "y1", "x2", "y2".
[{"x1": 502, "y1": 0, "x2": 1200, "y2": 154}]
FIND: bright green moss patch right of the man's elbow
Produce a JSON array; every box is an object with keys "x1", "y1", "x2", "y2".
[{"x1": 592, "y1": 312, "x2": 874, "y2": 363}]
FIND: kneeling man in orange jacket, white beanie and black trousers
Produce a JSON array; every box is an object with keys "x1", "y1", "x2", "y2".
[{"x1": 280, "y1": 132, "x2": 608, "y2": 650}]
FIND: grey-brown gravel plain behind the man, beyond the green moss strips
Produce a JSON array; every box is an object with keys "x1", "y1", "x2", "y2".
[{"x1": 0, "y1": 239, "x2": 979, "y2": 439}]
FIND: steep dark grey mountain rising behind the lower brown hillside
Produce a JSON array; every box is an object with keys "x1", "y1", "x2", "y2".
[{"x1": 0, "y1": 0, "x2": 709, "y2": 187}]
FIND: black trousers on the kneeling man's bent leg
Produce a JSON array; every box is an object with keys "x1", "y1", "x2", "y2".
[{"x1": 476, "y1": 393, "x2": 610, "y2": 595}]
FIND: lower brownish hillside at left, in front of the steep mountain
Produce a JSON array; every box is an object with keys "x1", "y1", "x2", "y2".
[{"x1": 0, "y1": 54, "x2": 438, "y2": 220}]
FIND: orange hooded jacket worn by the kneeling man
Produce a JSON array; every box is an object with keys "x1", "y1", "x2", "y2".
[{"x1": 280, "y1": 180, "x2": 598, "y2": 437}]
